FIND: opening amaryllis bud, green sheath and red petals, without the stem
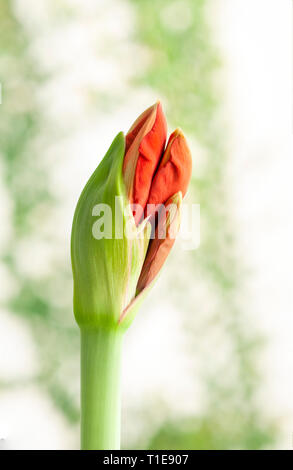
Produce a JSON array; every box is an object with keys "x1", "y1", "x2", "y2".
[{"x1": 71, "y1": 102, "x2": 191, "y2": 328}]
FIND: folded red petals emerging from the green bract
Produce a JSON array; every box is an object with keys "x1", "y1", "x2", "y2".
[{"x1": 123, "y1": 102, "x2": 192, "y2": 294}]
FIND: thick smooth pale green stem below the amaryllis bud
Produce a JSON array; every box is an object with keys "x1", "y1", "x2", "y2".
[{"x1": 81, "y1": 328, "x2": 122, "y2": 450}]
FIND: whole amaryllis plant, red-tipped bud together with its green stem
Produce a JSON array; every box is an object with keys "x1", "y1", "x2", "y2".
[{"x1": 71, "y1": 102, "x2": 191, "y2": 449}]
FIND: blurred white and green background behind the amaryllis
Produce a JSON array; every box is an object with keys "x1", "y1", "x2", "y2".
[{"x1": 0, "y1": 0, "x2": 293, "y2": 449}]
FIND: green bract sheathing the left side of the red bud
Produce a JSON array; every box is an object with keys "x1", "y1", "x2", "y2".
[{"x1": 71, "y1": 132, "x2": 150, "y2": 328}]
